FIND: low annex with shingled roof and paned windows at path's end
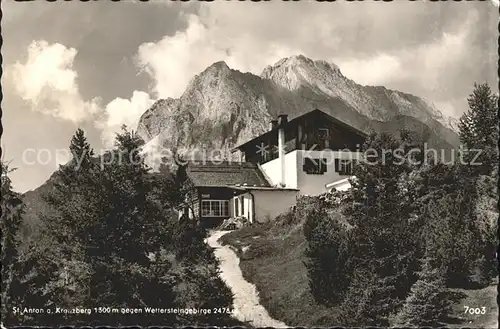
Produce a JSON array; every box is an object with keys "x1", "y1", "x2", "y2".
[{"x1": 180, "y1": 160, "x2": 299, "y2": 226}]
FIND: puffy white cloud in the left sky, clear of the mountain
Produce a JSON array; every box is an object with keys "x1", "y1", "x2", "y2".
[{"x1": 7, "y1": 40, "x2": 157, "y2": 147}]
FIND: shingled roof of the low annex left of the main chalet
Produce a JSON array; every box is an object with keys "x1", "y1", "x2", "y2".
[{"x1": 186, "y1": 160, "x2": 271, "y2": 187}]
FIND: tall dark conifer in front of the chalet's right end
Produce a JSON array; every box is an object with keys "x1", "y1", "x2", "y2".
[{"x1": 338, "y1": 133, "x2": 419, "y2": 325}]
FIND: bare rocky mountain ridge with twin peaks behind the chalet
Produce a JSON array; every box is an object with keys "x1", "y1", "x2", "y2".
[{"x1": 137, "y1": 55, "x2": 458, "y2": 164}]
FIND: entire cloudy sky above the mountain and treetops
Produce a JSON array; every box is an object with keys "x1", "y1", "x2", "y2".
[{"x1": 1, "y1": 0, "x2": 498, "y2": 192}]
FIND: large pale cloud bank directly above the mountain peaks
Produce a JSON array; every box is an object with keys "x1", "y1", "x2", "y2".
[{"x1": 133, "y1": 1, "x2": 496, "y2": 119}]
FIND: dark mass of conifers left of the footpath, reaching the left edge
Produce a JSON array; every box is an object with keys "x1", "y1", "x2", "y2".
[{"x1": 1, "y1": 127, "x2": 239, "y2": 326}]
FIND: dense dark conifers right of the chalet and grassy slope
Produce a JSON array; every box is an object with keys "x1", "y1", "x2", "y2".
[{"x1": 304, "y1": 84, "x2": 499, "y2": 326}]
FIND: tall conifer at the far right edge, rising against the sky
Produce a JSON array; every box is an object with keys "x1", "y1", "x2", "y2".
[{"x1": 459, "y1": 83, "x2": 500, "y2": 284}]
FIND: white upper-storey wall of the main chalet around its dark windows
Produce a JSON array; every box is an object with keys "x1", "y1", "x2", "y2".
[{"x1": 297, "y1": 150, "x2": 361, "y2": 196}]
